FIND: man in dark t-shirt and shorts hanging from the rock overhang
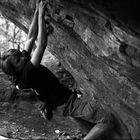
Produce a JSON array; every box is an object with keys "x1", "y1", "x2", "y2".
[{"x1": 2, "y1": 1, "x2": 118, "y2": 140}]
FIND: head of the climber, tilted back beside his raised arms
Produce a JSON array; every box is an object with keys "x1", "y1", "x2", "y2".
[{"x1": 1, "y1": 49, "x2": 25, "y2": 76}]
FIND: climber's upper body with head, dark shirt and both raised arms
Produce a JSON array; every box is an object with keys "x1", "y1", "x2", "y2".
[{"x1": 2, "y1": 1, "x2": 70, "y2": 119}]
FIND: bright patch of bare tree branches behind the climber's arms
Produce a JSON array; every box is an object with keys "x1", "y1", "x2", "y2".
[{"x1": 0, "y1": 14, "x2": 26, "y2": 53}]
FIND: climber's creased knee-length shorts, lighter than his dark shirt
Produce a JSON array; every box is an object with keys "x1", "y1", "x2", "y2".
[{"x1": 63, "y1": 94, "x2": 112, "y2": 127}]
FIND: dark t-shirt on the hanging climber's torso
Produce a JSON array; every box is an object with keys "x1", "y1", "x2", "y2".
[{"x1": 17, "y1": 50, "x2": 71, "y2": 108}]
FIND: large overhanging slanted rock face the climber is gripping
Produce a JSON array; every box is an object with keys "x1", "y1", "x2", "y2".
[{"x1": 0, "y1": 0, "x2": 140, "y2": 139}]
